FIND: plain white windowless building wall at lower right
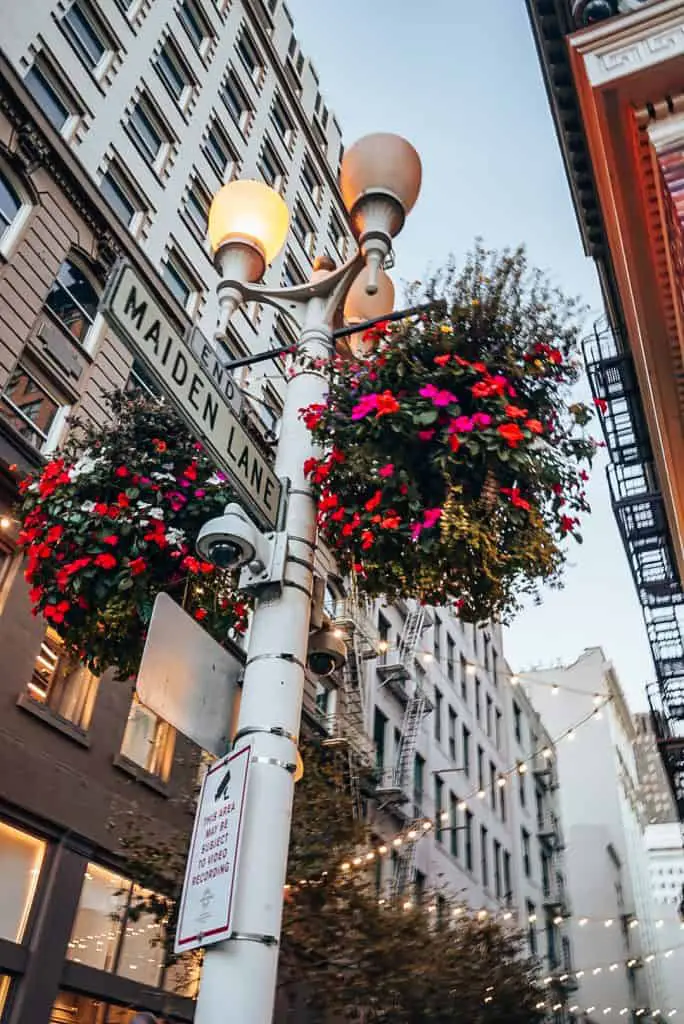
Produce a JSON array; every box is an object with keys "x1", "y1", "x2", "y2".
[{"x1": 523, "y1": 647, "x2": 676, "y2": 1019}]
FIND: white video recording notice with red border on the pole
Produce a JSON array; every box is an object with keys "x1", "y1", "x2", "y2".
[{"x1": 175, "y1": 744, "x2": 252, "y2": 953}]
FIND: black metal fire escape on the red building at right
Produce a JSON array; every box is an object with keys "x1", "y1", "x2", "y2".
[{"x1": 584, "y1": 319, "x2": 684, "y2": 820}]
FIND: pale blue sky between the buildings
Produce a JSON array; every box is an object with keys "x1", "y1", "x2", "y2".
[{"x1": 288, "y1": 0, "x2": 653, "y2": 711}]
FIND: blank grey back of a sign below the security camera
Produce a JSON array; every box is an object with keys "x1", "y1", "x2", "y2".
[{"x1": 135, "y1": 594, "x2": 243, "y2": 757}]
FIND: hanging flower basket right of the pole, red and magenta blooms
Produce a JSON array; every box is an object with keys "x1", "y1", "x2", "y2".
[{"x1": 301, "y1": 245, "x2": 596, "y2": 622}]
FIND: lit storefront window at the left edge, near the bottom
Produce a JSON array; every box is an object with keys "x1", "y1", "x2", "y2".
[{"x1": 0, "y1": 821, "x2": 45, "y2": 937}]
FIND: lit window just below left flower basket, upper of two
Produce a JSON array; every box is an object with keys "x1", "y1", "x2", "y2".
[{"x1": 27, "y1": 627, "x2": 98, "y2": 731}]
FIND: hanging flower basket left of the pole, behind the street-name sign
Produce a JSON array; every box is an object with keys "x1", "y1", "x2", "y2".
[{"x1": 19, "y1": 394, "x2": 248, "y2": 678}]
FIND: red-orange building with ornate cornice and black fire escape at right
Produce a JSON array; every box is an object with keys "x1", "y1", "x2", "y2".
[{"x1": 527, "y1": 0, "x2": 684, "y2": 818}]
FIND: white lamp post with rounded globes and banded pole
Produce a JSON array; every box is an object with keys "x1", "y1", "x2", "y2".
[{"x1": 195, "y1": 134, "x2": 421, "y2": 1024}]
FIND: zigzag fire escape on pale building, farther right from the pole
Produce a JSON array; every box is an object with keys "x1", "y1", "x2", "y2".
[{"x1": 376, "y1": 606, "x2": 432, "y2": 896}]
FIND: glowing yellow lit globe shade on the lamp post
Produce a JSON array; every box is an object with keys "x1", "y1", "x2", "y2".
[{"x1": 209, "y1": 180, "x2": 290, "y2": 266}]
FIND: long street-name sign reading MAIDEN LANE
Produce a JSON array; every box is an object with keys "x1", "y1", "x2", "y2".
[{"x1": 101, "y1": 264, "x2": 281, "y2": 529}]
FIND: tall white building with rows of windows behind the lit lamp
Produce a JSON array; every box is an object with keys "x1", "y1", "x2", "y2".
[{"x1": 2, "y1": 0, "x2": 351, "y2": 432}]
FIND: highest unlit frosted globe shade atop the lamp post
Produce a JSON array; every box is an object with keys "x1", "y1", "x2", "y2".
[{"x1": 340, "y1": 132, "x2": 422, "y2": 224}]
